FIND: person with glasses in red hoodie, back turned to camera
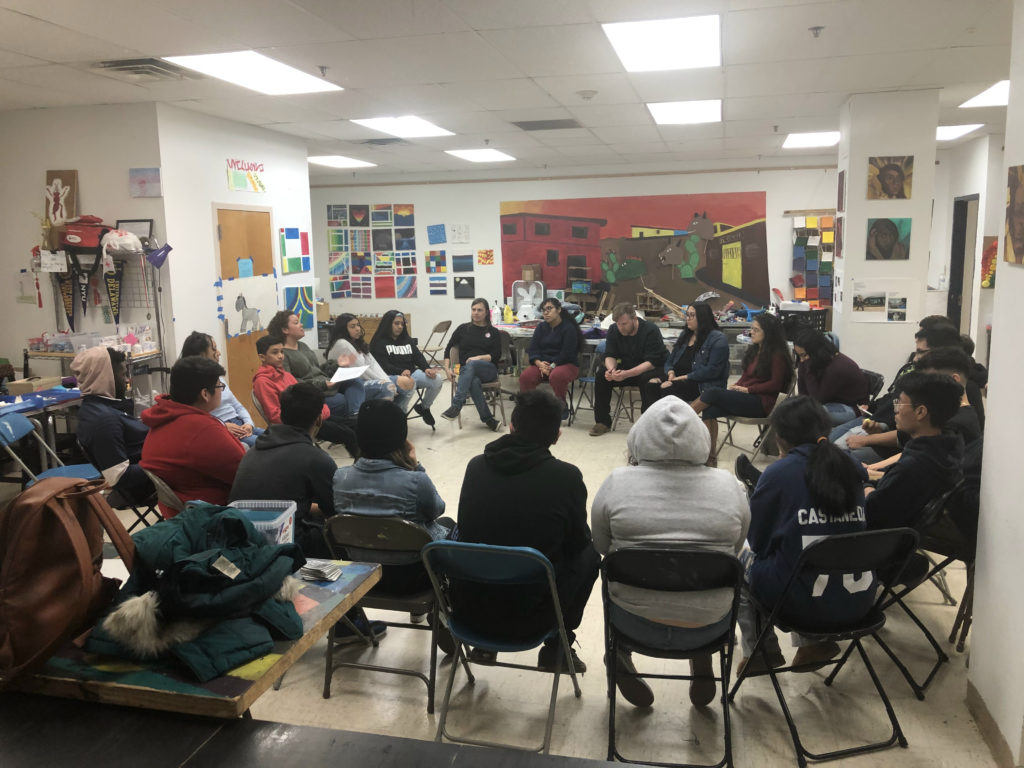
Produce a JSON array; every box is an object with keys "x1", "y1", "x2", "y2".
[{"x1": 139, "y1": 356, "x2": 246, "y2": 517}]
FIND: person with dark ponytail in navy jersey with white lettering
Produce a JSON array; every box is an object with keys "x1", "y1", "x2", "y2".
[{"x1": 738, "y1": 395, "x2": 874, "y2": 671}]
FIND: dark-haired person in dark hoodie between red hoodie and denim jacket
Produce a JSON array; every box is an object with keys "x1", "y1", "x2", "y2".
[{"x1": 229, "y1": 382, "x2": 338, "y2": 557}]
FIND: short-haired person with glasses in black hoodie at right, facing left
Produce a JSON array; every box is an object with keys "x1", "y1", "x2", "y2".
[{"x1": 865, "y1": 371, "x2": 964, "y2": 529}]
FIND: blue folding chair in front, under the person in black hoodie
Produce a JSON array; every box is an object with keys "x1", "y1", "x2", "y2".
[{"x1": 421, "y1": 542, "x2": 581, "y2": 755}]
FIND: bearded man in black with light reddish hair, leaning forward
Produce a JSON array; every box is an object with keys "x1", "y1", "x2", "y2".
[{"x1": 590, "y1": 302, "x2": 669, "y2": 437}]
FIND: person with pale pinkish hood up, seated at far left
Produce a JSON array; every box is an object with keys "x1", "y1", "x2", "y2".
[{"x1": 71, "y1": 347, "x2": 153, "y2": 507}]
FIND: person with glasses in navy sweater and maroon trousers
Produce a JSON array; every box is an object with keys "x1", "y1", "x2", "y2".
[{"x1": 519, "y1": 299, "x2": 587, "y2": 420}]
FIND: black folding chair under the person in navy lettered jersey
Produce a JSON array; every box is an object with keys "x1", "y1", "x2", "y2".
[{"x1": 729, "y1": 528, "x2": 918, "y2": 768}]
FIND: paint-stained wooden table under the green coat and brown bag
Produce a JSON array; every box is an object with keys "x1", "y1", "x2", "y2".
[{"x1": 14, "y1": 562, "x2": 381, "y2": 718}]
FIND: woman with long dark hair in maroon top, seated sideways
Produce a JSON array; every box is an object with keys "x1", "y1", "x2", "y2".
[{"x1": 690, "y1": 312, "x2": 793, "y2": 466}]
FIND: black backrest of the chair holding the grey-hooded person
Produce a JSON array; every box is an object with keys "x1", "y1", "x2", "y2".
[{"x1": 601, "y1": 546, "x2": 743, "y2": 592}]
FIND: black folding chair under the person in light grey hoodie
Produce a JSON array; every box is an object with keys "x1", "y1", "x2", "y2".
[{"x1": 601, "y1": 547, "x2": 743, "y2": 768}]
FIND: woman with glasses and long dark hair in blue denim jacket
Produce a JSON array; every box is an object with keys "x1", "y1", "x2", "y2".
[{"x1": 648, "y1": 301, "x2": 729, "y2": 402}]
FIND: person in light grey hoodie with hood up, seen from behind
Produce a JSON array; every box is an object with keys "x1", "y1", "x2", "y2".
[{"x1": 591, "y1": 397, "x2": 751, "y2": 707}]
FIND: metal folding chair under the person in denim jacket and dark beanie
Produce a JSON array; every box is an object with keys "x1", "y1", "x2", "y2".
[{"x1": 324, "y1": 515, "x2": 437, "y2": 714}]
